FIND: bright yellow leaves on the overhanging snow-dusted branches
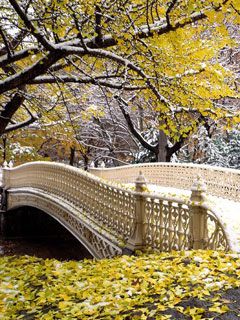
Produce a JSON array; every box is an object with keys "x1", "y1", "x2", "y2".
[{"x1": 0, "y1": 0, "x2": 239, "y2": 140}]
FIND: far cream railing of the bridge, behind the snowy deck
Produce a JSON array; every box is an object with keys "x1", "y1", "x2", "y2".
[{"x1": 89, "y1": 162, "x2": 240, "y2": 201}]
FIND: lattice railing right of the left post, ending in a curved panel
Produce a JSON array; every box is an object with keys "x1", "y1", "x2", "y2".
[{"x1": 138, "y1": 194, "x2": 232, "y2": 251}]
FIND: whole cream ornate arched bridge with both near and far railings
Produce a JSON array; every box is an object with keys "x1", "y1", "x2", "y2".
[{"x1": 1, "y1": 162, "x2": 240, "y2": 259}]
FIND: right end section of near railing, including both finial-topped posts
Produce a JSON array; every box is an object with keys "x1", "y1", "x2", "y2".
[{"x1": 125, "y1": 173, "x2": 232, "y2": 251}]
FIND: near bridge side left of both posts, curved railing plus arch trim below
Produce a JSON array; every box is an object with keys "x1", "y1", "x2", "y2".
[{"x1": 2, "y1": 162, "x2": 135, "y2": 257}]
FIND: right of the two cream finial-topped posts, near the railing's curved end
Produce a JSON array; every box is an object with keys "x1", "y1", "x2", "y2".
[{"x1": 190, "y1": 176, "x2": 208, "y2": 249}]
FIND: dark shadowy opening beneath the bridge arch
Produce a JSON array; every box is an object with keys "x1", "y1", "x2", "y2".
[{"x1": 0, "y1": 206, "x2": 93, "y2": 260}]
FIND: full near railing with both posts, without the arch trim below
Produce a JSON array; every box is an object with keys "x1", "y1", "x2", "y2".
[{"x1": 0, "y1": 162, "x2": 231, "y2": 255}]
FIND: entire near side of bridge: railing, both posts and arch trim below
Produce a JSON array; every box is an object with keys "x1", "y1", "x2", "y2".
[{"x1": 2, "y1": 162, "x2": 231, "y2": 258}]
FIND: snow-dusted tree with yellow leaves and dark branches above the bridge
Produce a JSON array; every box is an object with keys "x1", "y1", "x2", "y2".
[{"x1": 0, "y1": 0, "x2": 240, "y2": 161}]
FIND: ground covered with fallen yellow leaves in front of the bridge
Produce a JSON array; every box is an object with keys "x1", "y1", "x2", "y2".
[{"x1": 0, "y1": 251, "x2": 240, "y2": 320}]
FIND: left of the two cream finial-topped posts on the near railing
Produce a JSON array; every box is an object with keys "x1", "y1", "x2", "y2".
[{"x1": 123, "y1": 171, "x2": 146, "y2": 253}]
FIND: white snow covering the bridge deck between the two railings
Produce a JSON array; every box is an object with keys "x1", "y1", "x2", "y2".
[{"x1": 125, "y1": 184, "x2": 240, "y2": 252}]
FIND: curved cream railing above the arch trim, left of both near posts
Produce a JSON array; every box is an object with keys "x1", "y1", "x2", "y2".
[{"x1": 3, "y1": 162, "x2": 135, "y2": 239}]
